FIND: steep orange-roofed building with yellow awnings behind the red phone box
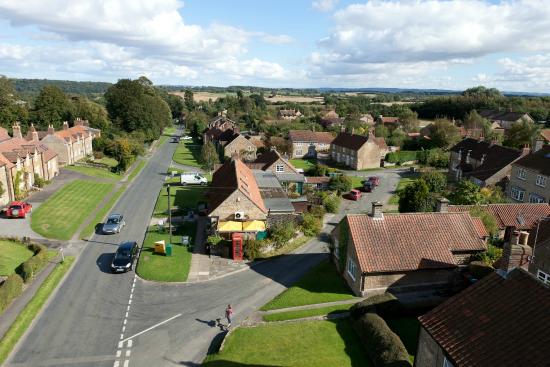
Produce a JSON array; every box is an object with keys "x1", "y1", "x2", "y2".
[{"x1": 207, "y1": 158, "x2": 268, "y2": 238}]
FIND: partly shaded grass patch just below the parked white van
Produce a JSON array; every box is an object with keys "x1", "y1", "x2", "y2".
[{"x1": 153, "y1": 186, "x2": 207, "y2": 217}]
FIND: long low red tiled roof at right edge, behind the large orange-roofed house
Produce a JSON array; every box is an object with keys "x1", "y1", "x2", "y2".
[{"x1": 448, "y1": 203, "x2": 550, "y2": 230}]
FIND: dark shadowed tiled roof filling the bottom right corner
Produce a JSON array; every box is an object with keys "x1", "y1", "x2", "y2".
[{"x1": 419, "y1": 269, "x2": 550, "y2": 367}]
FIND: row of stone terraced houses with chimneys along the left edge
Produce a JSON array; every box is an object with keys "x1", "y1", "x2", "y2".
[{"x1": 0, "y1": 119, "x2": 101, "y2": 205}]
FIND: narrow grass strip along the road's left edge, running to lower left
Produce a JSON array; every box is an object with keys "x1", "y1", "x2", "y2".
[{"x1": 0, "y1": 256, "x2": 75, "y2": 364}]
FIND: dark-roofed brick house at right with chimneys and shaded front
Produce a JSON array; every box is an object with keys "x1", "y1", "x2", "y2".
[{"x1": 449, "y1": 138, "x2": 529, "y2": 187}]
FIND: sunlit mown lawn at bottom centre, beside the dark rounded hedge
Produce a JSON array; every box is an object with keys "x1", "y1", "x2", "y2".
[{"x1": 203, "y1": 319, "x2": 372, "y2": 367}]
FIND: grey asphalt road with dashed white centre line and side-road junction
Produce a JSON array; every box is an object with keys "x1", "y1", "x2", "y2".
[{"x1": 9, "y1": 134, "x2": 408, "y2": 367}]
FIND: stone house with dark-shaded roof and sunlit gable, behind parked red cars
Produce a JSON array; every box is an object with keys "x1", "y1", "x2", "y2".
[{"x1": 330, "y1": 132, "x2": 388, "y2": 170}]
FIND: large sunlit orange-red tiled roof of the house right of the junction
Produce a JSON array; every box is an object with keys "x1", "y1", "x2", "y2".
[{"x1": 344, "y1": 213, "x2": 486, "y2": 272}]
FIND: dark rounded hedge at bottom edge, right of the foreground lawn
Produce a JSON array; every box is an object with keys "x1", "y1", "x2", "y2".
[{"x1": 353, "y1": 312, "x2": 411, "y2": 367}]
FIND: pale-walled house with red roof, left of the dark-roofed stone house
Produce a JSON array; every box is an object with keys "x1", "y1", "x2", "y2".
[{"x1": 288, "y1": 130, "x2": 334, "y2": 158}]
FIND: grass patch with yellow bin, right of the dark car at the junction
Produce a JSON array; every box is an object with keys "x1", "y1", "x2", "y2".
[{"x1": 136, "y1": 222, "x2": 196, "y2": 282}]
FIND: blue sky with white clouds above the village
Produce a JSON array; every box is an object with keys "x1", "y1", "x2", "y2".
[{"x1": 0, "y1": 0, "x2": 550, "y2": 93}]
